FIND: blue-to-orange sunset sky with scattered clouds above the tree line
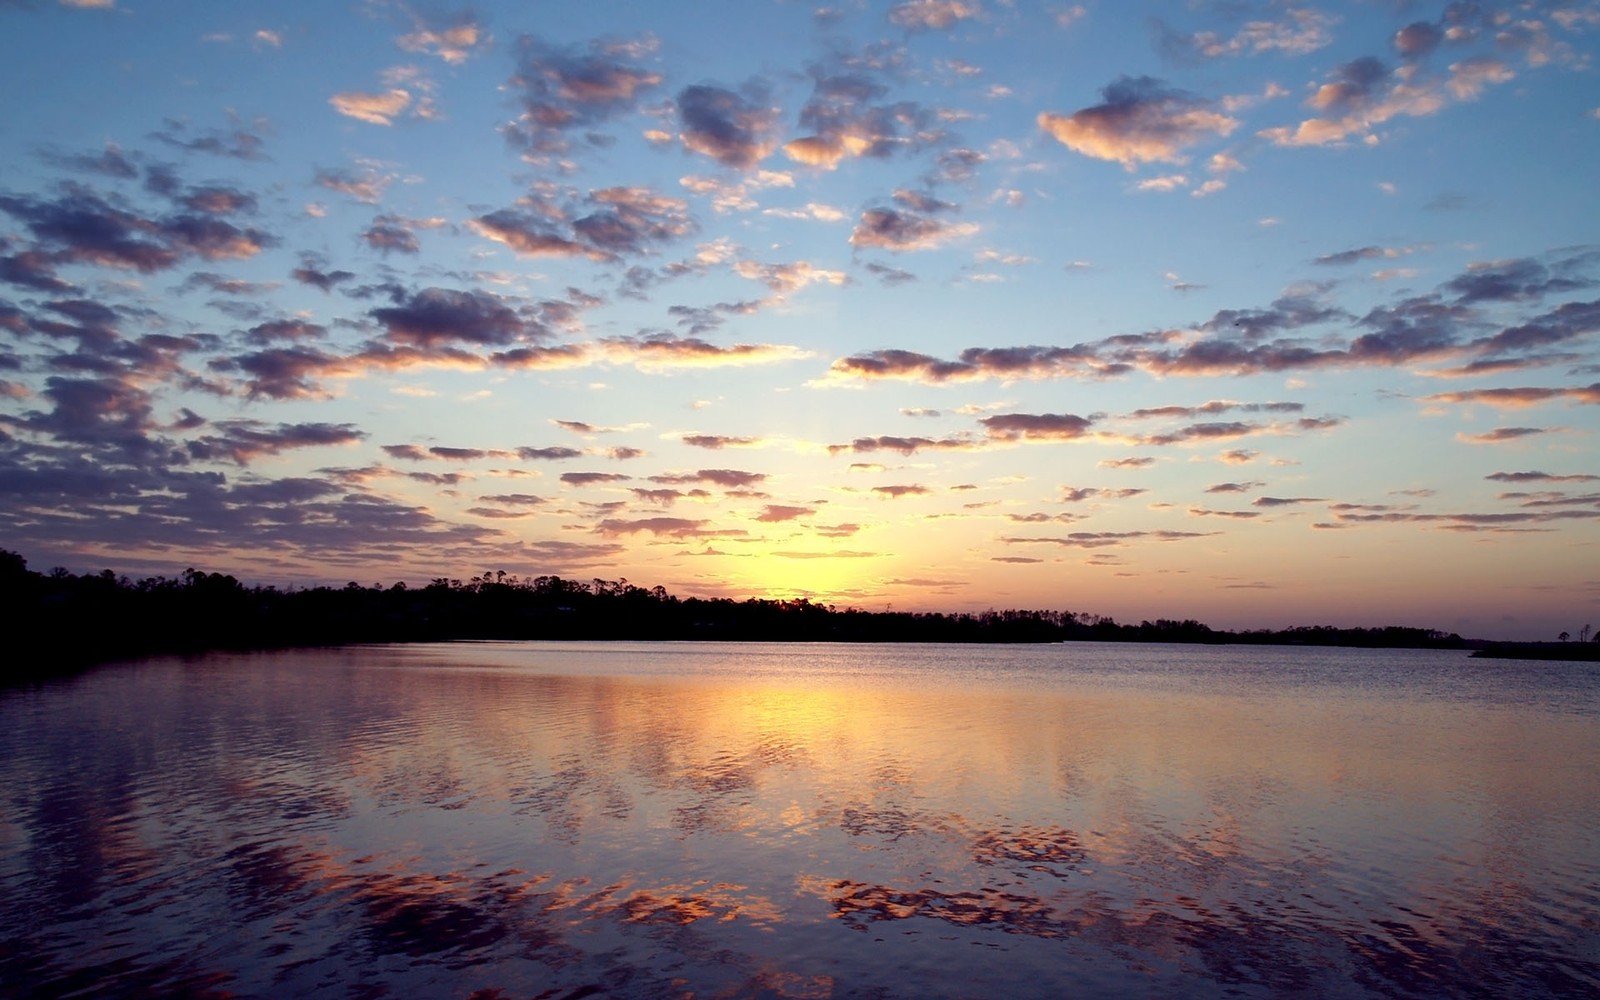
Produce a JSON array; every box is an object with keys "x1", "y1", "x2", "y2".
[{"x1": 0, "y1": 0, "x2": 1600, "y2": 638}]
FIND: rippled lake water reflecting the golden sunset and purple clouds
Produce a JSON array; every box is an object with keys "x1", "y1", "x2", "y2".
[{"x1": 0, "y1": 643, "x2": 1600, "y2": 1000}]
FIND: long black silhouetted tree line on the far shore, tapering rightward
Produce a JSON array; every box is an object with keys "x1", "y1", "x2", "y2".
[{"x1": 0, "y1": 550, "x2": 1467, "y2": 680}]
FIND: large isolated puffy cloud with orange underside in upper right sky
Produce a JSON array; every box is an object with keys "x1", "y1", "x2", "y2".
[{"x1": 1038, "y1": 77, "x2": 1238, "y2": 170}]
